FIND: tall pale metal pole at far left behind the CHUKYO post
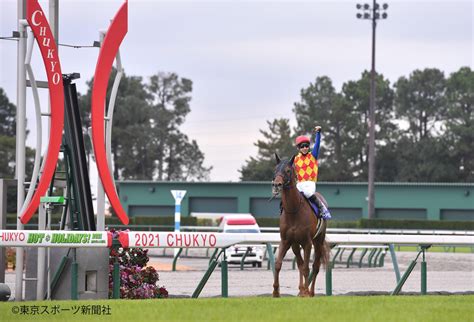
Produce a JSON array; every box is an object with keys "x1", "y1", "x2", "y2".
[{"x1": 15, "y1": 0, "x2": 26, "y2": 301}]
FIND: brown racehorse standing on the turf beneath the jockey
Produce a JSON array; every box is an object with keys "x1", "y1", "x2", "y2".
[{"x1": 272, "y1": 153, "x2": 330, "y2": 297}]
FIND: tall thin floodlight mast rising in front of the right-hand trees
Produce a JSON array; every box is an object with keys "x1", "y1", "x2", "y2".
[{"x1": 368, "y1": 0, "x2": 377, "y2": 219}]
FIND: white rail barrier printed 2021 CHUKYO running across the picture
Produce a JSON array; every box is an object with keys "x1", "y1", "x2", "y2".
[{"x1": 0, "y1": 230, "x2": 474, "y2": 248}]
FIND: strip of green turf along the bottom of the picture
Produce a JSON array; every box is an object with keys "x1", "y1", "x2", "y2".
[{"x1": 0, "y1": 295, "x2": 474, "y2": 322}]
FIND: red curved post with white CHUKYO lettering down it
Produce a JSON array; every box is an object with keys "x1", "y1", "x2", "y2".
[{"x1": 20, "y1": 0, "x2": 64, "y2": 224}]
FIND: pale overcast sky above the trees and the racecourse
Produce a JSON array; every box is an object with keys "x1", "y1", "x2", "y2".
[{"x1": 0, "y1": 0, "x2": 474, "y2": 181}]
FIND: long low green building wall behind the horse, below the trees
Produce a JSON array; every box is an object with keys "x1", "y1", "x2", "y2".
[{"x1": 118, "y1": 181, "x2": 474, "y2": 221}]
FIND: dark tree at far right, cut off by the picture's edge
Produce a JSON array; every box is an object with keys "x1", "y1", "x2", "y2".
[{"x1": 442, "y1": 67, "x2": 474, "y2": 182}]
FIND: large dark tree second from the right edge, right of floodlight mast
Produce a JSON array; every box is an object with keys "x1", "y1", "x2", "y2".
[{"x1": 395, "y1": 68, "x2": 462, "y2": 182}]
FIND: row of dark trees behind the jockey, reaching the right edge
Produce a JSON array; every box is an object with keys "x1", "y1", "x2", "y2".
[{"x1": 241, "y1": 67, "x2": 474, "y2": 182}]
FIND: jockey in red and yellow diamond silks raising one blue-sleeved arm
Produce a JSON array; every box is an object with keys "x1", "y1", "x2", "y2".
[{"x1": 294, "y1": 126, "x2": 331, "y2": 218}]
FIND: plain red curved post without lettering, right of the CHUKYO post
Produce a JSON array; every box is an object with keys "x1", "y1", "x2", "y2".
[{"x1": 91, "y1": 1, "x2": 128, "y2": 225}]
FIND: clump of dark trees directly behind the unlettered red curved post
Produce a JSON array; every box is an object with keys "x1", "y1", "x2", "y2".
[{"x1": 80, "y1": 70, "x2": 211, "y2": 181}]
